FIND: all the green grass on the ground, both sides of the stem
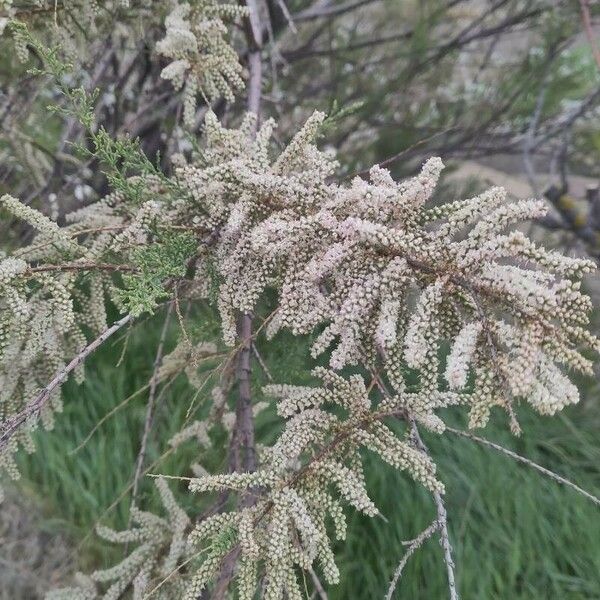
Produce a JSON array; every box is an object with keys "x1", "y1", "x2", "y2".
[{"x1": 14, "y1": 310, "x2": 600, "y2": 600}]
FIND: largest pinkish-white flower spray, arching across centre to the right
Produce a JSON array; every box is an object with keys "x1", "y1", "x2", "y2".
[{"x1": 171, "y1": 113, "x2": 598, "y2": 429}]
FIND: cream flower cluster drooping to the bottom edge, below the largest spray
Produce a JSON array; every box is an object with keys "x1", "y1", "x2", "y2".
[{"x1": 185, "y1": 368, "x2": 443, "y2": 600}]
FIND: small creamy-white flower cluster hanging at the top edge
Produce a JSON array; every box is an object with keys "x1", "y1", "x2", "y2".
[{"x1": 156, "y1": 0, "x2": 247, "y2": 126}]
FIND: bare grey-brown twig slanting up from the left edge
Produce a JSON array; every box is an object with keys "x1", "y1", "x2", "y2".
[{"x1": 0, "y1": 315, "x2": 132, "y2": 450}]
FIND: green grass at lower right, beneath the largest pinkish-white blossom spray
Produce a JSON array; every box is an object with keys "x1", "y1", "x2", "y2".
[{"x1": 331, "y1": 406, "x2": 600, "y2": 600}]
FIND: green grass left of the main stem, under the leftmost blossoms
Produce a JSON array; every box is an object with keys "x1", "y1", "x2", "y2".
[{"x1": 18, "y1": 308, "x2": 225, "y2": 564}]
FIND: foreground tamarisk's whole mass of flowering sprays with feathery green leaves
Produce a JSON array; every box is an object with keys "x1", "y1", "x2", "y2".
[{"x1": 0, "y1": 112, "x2": 598, "y2": 599}]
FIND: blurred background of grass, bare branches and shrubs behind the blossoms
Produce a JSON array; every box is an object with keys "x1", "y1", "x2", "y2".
[{"x1": 0, "y1": 0, "x2": 600, "y2": 600}]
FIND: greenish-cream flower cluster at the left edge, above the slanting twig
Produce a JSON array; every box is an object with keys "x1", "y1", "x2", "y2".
[{"x1": 0, "y1": 195, "x2": 133, "y2": 494}]
